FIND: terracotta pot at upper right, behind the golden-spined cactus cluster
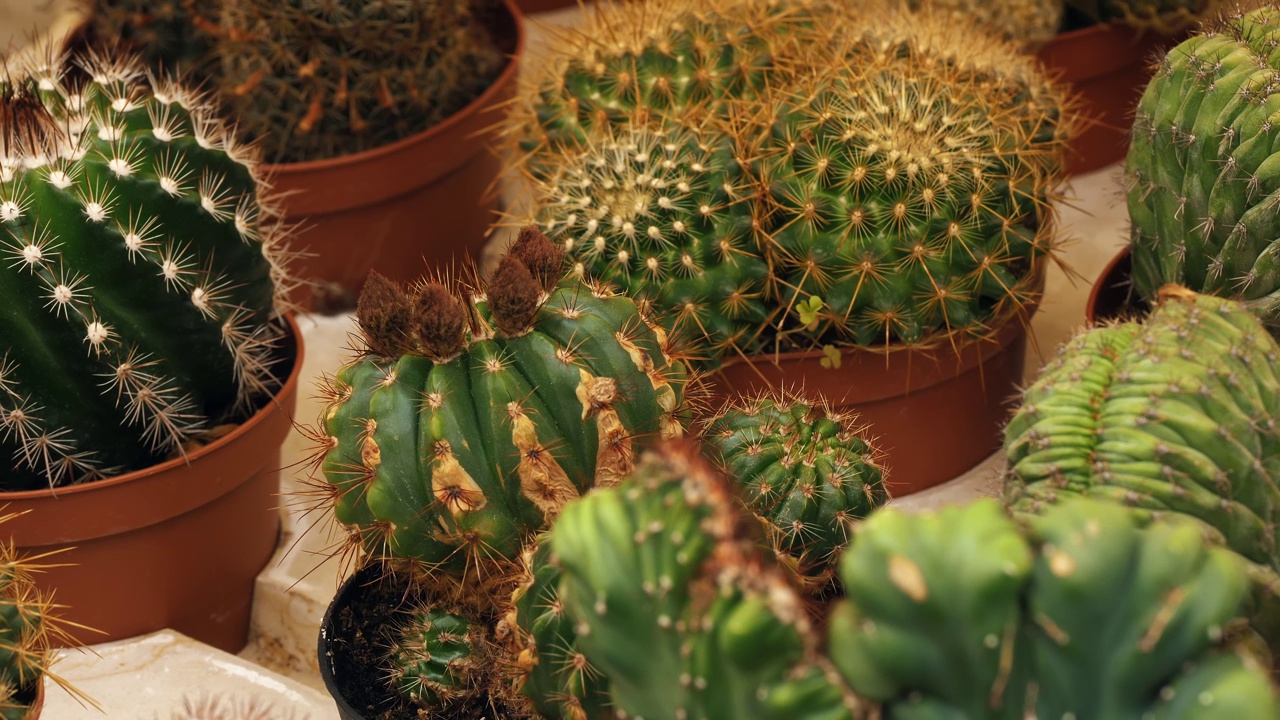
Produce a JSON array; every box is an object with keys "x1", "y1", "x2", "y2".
[{"x1": 1036, "y1": 23, "x2": 1185, "y2": 174}]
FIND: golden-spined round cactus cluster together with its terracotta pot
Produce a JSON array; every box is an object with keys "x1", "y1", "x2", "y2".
[{"x1": 509, "y1": 0, "x2": 1071, "y2": 495}]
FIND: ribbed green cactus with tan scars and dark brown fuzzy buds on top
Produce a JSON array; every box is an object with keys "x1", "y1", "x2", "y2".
[{"x1": 317, "y1": 228, "x2": 686, "y2": 584}]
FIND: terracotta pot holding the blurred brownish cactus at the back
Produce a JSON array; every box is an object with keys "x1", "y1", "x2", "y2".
[{"x1": 272, "y1": 0, "x2": 525, "y2": 311}]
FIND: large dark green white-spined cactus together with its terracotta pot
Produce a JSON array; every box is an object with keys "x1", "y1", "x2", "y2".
[{"x1": 0, "y1": 46, "x2": 302, "y2": 651}]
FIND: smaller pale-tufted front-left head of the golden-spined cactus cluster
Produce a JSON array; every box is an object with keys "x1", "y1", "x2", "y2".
[{"x1": 540, "y1": 128, "x2": 769, "y2": 358}]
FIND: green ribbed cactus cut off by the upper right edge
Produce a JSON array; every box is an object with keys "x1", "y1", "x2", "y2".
[{"x1": 1125, "y1": 5, "x2": 1280, "y2": 319}]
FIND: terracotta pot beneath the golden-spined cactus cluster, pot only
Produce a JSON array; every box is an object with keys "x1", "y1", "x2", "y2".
[{"x1": 713, "y1": 306, "x2": 1036, "y2": 497}]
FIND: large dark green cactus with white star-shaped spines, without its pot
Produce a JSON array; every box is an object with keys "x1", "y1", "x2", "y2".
[{"x1": 0, "y1": 49, "x2": 288, "y2": 489}]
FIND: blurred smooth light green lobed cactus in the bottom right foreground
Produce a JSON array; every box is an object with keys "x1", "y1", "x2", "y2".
[{"x1": 829, "y1": 500, "x2": 1280, "y2": 720}]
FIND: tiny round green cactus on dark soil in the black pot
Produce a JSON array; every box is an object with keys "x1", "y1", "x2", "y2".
[{"x1": 390, "y1": 606, "x2": 488, "y2": 707}]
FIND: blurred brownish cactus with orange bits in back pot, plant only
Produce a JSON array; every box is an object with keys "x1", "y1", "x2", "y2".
[{"x1": 215, "y1": 0, "x2": 503, "y2": 163}]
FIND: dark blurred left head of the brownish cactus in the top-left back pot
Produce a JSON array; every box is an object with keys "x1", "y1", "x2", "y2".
[{"x1": 91, "y1": 0, "x2": 218, "y2": 72}]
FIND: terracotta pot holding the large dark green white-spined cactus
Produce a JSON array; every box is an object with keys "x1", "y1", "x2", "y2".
[{"x1": 0, "y1": 318, "x2": 303, "y2": 652}]
